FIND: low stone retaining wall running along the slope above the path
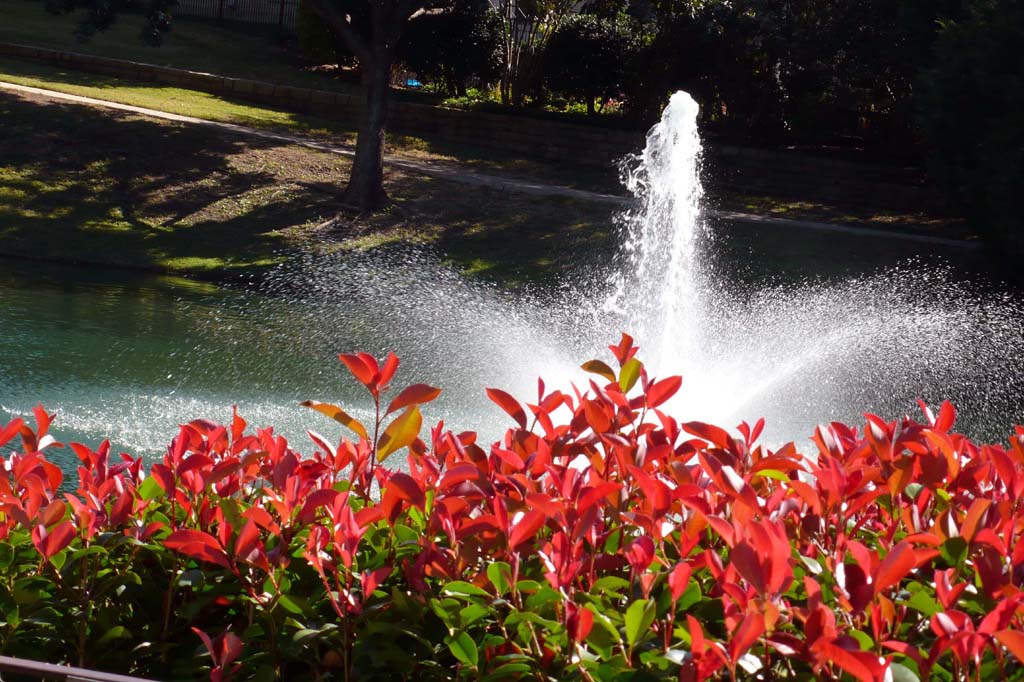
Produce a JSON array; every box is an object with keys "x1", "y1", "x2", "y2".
[{"x1": 0, "y1": 43, "x2": 939, "y2": 210}]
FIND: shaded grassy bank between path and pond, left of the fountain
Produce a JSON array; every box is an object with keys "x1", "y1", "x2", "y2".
[{"x1": 0, "y1": 88, "x2": 613, "y2": 286}]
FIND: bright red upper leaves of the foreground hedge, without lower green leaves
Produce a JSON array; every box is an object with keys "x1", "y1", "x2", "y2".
[{"x1": 0, "y1": 335, "x2": 1024, "y2": 680}]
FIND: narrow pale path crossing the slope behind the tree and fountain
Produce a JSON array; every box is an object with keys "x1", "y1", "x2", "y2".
[{"x1": 0, "y1": 81, "x2": 979, "y2": 249}]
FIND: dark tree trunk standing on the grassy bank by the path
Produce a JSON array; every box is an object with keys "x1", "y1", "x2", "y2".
[{"x1": 343, "y1": 49, "x2": 391, "y2": 211}]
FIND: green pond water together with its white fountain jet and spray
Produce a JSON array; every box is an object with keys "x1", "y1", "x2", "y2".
[{"x1": 0, "y1": 93, "x2": 1024, "y2": 454}]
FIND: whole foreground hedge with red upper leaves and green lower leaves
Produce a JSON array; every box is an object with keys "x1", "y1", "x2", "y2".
[{"x1": 0, "y1": 336, "x2": 1024, "y2": 681}]
